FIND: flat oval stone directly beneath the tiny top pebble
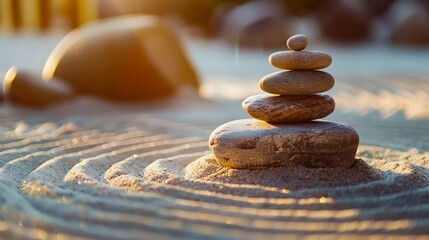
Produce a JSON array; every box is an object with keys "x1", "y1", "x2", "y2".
[{"x1": 268, "y1": 51, "x2": 332, "y2": 70}]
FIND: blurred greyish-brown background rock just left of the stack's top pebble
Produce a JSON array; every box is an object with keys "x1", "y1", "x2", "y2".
[{"x1": 220, "y1": 0, "x2": 290, "y2": 47}]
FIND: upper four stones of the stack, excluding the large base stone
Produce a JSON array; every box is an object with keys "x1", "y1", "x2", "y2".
[{"x1": 243, "y1": 35, "x2": 335, "y2": 123}]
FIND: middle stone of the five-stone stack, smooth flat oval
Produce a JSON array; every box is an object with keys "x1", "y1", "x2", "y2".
[{"x1": 259, "y1": 71, "x2": 335, "y2": 95}]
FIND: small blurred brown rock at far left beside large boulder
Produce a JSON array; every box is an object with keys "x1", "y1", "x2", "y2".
[{"x1": 3, "y1": 67, "x2": 73, "y2": 107}]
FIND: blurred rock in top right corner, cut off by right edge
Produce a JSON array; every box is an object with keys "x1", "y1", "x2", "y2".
[{"x1": 387, "y1": 1, "x2": 429, "y2": 47}]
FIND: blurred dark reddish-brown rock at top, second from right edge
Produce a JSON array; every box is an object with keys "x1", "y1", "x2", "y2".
[{"x1": 317, "y1": 0, "x2": 371, "y2": 42}]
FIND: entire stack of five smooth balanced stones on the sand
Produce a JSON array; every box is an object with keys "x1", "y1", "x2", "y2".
[{"x1": 209, "y1": 34, "x2": 359, "y2": 169}]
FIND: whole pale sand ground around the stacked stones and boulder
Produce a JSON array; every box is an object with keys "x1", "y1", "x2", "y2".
[{"x1": 0, "y1": 34, "x2": 429, "y2": 239}]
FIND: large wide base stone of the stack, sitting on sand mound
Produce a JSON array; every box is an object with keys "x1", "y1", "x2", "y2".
[{"x1": 209, "y1": 119, "x2": 359, "y2": 169}]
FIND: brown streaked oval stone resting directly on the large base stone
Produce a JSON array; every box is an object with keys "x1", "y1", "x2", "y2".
[{"x1": 242, "y1": 94, "x2": 335, "y2": 123}]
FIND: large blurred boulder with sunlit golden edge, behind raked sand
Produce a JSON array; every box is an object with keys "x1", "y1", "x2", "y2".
[{"x1": 43, "y1": 16, "x2": 199, "y2": 100}]
